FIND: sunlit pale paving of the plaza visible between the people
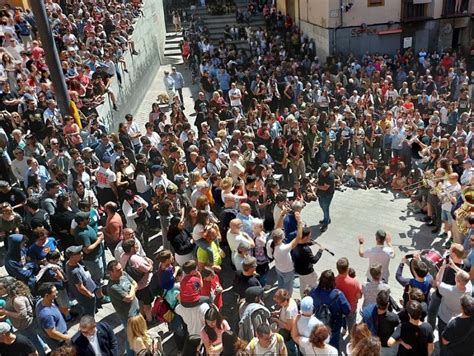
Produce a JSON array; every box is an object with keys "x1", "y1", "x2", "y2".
[{"x1": 0, "y1": 65, "x2": 441, "y2": 355}]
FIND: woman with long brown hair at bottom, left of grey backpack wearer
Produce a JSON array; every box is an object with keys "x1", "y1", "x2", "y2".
[{"x1": 201, "y1": 306, "x2": 230, "y2": 356}]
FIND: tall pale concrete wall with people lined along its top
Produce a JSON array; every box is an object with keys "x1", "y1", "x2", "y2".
[{"x1": 97, "y1": 0, "x2": 166, "y2": 130}]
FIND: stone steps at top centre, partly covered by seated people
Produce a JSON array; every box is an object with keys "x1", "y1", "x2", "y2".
[{"x1": 164, "y1": 0, "x2": 265, "y2": 64}]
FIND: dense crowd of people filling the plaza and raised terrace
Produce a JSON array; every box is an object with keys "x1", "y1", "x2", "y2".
[{"x1": 0, "y1": 0, "x2": 474, "y2": 356}]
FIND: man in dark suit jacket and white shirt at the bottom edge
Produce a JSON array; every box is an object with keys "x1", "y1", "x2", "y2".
[{"x1": 72, "y1": 315, "x2": 118, "y2": 356}]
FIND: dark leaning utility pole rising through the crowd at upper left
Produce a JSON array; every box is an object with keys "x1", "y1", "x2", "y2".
[{"x1": 29, "y1": 0, "x2": 71, "y2": 115}]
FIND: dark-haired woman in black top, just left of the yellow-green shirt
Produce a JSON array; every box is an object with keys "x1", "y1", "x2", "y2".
[{"x1": 166, "y1": 216, "x2": 194, "y2": 266}]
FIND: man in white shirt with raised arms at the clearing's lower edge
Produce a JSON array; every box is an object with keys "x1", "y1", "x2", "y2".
[{"x1": 359, "y1": 230, "x2": 395, "y2": 283}]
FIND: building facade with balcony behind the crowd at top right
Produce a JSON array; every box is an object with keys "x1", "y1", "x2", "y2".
[{"x1": 277, "y1": 0, "x2": 474, "y2": 59}]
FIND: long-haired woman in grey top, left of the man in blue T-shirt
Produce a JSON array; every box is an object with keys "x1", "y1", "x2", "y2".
[{"x1": 0, "y1": 281, "x2": 47, "y2": 355}]
